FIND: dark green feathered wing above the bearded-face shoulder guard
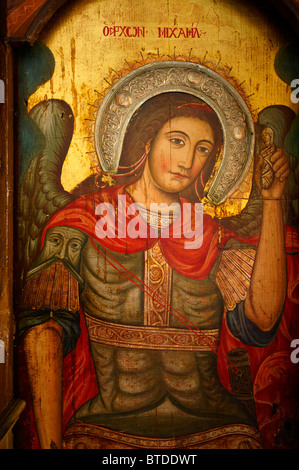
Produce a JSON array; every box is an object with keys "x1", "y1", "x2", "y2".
[{"x1": 18, "y1": 99, "x2": 74, "y2": 279}]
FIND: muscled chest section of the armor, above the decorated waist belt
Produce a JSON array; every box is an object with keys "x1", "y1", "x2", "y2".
[{"x1": 81, "y1": 242, "x2": 223, "y2": 330}]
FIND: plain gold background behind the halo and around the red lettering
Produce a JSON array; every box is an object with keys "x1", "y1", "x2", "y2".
[{"x1": 28, "y1": 0, "x2": 296, "y2": 215}]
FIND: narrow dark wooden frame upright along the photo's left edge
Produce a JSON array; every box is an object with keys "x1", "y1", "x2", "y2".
[{"x1": 0, "y1": 10, "x2": 14, "y2": 448}]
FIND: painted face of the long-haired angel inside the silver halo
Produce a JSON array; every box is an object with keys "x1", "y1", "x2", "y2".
[{"x1": 147, "y1": 117, "x2": 215, "y2": 193}]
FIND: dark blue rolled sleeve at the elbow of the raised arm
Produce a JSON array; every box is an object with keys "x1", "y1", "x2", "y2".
[{"x1": 226, "y1": 302, "x2": 281, "y2": 348}]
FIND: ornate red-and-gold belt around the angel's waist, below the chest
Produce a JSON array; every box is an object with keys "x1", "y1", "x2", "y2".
[{"x1": 85, "y1": 313, "x2": 219, "y2": 351}]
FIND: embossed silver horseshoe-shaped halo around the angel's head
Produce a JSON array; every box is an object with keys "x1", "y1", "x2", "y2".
[{"x1": 95, "y1": 61, "x2": 254, "y2": 205}]
